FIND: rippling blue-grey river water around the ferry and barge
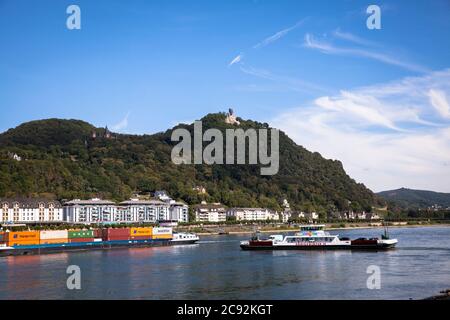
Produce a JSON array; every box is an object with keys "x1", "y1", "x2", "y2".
[{"x1": 0, "y1": 227, "x2": 450, "y2": 299}]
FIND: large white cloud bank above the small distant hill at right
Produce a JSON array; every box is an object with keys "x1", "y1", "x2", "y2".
[{"x1": 271, "y1": 69, "x2": 450, "y2": 192}]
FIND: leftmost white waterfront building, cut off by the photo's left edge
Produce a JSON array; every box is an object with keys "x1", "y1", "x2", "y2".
[{"x1": 0, "y1": 198, "x2": 63, "y2": 223}]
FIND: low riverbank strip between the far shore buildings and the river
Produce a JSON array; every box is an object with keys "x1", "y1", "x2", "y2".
[{"x1": 177, "y1": 222, "x2": 450, "y2": 236}]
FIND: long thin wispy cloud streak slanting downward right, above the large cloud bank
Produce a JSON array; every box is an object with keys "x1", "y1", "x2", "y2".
[{"x1": 304, "y1": 33, "x2": 430, "y2": 73}]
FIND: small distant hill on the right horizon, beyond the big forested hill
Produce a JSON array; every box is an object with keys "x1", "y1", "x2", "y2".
[{"x1": 377, "y1": 188, "x2": 450, "y2": 208}]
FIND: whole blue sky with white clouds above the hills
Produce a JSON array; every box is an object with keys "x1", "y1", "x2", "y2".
[{"x1": 0, "y1": 0, "x2": 450, "y2": 192}]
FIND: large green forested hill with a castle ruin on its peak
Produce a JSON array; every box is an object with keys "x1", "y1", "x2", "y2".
[{"x1": 0, "y1": 113, "x2": 383, "y2": 212}]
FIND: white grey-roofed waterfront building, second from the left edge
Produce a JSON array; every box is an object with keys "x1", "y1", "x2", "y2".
[{"x1": 64, "y1": 198, "x2": 117, "y2": 223}]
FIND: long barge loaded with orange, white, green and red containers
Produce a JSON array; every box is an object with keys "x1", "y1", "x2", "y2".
[{"x1": 0, "y1": 228, "x2": 199, "y2": 257}]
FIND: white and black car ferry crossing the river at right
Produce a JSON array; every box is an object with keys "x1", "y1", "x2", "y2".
[{"x1": 241, "y1": 225, "x2": 398, "y2": 250}]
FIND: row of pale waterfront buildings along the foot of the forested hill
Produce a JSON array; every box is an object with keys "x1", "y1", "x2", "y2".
[{"x1": 0, "y1": 191, "x2": 380, "y2": 223}]
